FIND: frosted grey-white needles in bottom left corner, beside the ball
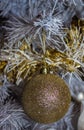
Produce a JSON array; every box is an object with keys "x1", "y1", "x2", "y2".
[{"x1": 0, "y1": 101, "x2": 31, "y2": 130}]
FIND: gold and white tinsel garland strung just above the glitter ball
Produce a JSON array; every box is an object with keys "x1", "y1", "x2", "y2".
[{"x1": 0, "y1": 18, "x2": 84, "y2": 84}]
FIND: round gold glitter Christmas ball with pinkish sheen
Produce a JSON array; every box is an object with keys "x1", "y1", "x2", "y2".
[{"x1": 22, "y1": 74, "x2": 71, "y2": 123}]
